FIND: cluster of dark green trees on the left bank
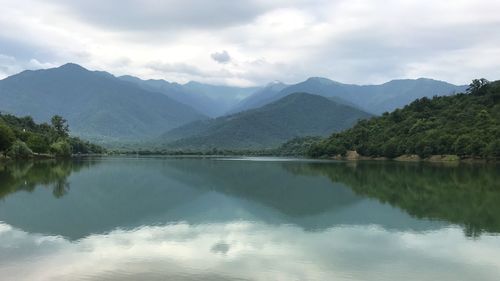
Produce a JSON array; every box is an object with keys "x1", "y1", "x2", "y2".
[{"x1": 0, "y1": 114, "x2": 105, "y2": 158}]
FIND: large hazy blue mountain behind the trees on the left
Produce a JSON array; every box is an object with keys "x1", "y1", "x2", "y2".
[{"x1": 0, "y1": 63, "x2": 206, "y2": 141}]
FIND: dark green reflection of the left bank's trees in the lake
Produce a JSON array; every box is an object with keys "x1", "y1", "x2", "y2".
[{"x1": 0, "y1": 160, "x2": 96, "y2": 198}]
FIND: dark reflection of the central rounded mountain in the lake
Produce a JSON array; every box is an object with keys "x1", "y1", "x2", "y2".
[{"x1": 158, "y1": 160, "x2": 361, "y2": 217}]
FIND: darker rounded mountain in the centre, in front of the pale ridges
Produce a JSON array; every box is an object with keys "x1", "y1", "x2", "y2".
[{"x1": 162, "y1": 93, "x2": 371, "y2": 149}]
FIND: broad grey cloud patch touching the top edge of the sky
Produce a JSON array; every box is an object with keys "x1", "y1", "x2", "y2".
[{"x1": 47, "y1": 0, "x2": 286, "y2": 31}]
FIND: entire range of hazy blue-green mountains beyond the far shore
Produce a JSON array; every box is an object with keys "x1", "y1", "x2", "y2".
[{"x1": 0, "y1": 63, "x2": 466, "y2": 148}]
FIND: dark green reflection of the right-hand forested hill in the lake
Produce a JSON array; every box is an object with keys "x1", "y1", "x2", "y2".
[{"x1": 286, "y1": 162, "x2": 500, "y2": 237}]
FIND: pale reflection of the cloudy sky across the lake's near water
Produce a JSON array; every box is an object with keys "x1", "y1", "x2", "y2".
[{"x1": 0, "y1": 222, "x2": 500, "y2": 281}]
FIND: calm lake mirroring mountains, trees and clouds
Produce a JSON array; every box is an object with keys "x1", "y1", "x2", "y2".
[{"x1": 0, "y1": 157, "x2": 500, "y2": 281}]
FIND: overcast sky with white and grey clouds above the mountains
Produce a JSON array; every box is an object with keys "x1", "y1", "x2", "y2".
[{"x1": 0, "y1": 0, "x2": 500, "y2": 86}]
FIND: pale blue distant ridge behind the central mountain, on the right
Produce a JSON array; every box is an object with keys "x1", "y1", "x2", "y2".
[{"x1": 232, "y1": 77, "x2": 467, "y2": 114}]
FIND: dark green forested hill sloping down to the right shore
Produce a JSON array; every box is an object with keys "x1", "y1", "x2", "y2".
[{"x1": 309, "y1": 79, "x2": 500, "y2": 158}]
